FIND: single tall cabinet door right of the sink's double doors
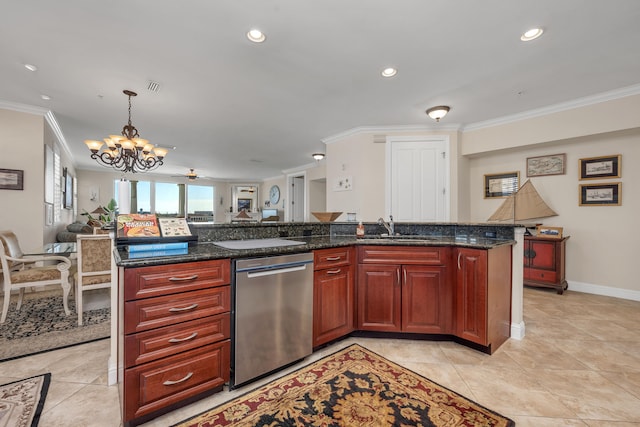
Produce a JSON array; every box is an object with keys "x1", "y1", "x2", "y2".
[{"x1": 455, "y1": 248, "x2": 487, "y2": 345}]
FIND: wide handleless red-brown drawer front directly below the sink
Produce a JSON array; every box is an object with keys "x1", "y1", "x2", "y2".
[{"x1": 358, "y1": 246, "x2": 451, "y2": 265}]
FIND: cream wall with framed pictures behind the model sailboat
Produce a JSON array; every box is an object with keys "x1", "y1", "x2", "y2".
[{"x1": 469, "y1": 129, "x2": 640, "y2": 298}]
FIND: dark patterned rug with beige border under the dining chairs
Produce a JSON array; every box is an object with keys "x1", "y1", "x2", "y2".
[{"x1": 0, "y1": 291, "x2": 111, "y2": 362}]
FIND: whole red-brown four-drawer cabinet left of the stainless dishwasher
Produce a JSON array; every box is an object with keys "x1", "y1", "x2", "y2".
[{"x1": 121, "y1": 259, "x2": 231, "y2": 425}]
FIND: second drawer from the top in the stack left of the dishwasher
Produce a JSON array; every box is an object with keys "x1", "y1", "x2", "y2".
[{"x1": 124, "y1": 285, "x2": 231, "y2": 334}]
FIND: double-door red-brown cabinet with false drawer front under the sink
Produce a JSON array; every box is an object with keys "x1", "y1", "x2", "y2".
[{"x1": 357, "y1": 246, "x2": 452, "y2": 334}]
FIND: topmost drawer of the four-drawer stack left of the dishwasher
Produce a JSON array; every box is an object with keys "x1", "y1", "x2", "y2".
[{"x1": 124, "y1": 259, "x2": 231, "y2": 301}]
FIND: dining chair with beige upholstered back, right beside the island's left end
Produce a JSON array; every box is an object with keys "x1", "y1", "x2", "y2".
[{"x1": 74, "y1": 234, "x2": 113, "y2": 326}]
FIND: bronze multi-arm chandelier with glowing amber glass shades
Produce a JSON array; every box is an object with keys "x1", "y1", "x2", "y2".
[{"x1": 84, "y1": 90, "x2": 167, "y2": 173}]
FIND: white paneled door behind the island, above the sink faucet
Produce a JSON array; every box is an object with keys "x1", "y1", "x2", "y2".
[{"x1": 387, "y1": 137, "x2": 449, "y2": 222}]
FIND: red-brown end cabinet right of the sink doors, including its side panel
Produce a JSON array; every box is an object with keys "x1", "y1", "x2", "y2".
[{"x1": 454, "y1": 245, "x2": 511, "y2": 353}]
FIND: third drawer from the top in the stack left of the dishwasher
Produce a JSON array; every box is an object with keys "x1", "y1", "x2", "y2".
[{"x1": 124, "y1": 313, "x2": 231, "y2": 368}]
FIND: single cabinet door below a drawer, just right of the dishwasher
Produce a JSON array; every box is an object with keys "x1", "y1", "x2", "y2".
[{"x1": 313, "y1": 265, "x2": 355, "y2": 347}]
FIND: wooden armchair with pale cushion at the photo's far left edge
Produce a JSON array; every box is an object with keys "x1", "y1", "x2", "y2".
[{"x1": 0, "y1": 230, "x2": 71, "y2": 323}]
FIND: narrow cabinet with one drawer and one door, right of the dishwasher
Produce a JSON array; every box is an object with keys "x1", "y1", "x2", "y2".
[{"x1": 313, "y1": 247, "x2": 355, "y2": 347}]
